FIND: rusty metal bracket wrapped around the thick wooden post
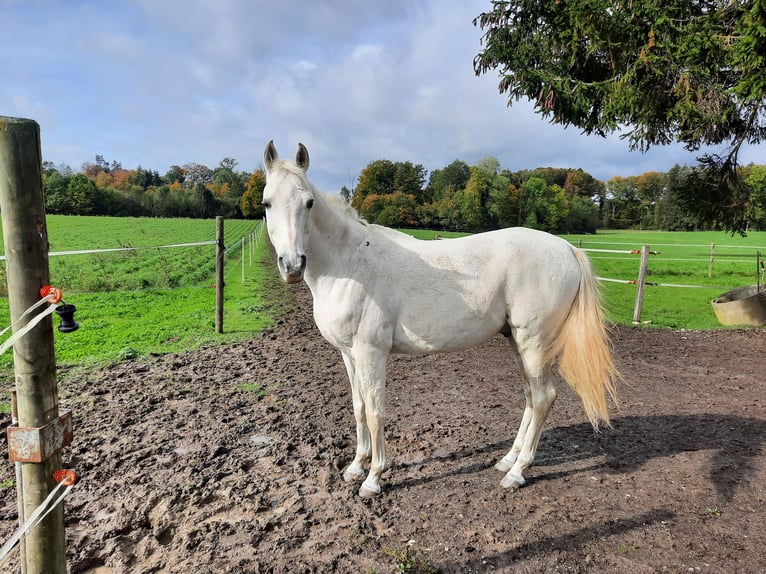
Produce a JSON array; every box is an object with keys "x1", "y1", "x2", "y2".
[{"x1": 7, "y1": 411, "x2": 74, "y2": 462}]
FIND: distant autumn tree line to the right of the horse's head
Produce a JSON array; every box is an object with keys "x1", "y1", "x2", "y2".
[{"x1": 341, "y1": 158, "x2": 766, "y2": 233}]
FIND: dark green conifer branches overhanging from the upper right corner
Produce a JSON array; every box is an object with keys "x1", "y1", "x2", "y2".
[{"x1": 474, "y1": 0, "x2": 766, "y2": 231}]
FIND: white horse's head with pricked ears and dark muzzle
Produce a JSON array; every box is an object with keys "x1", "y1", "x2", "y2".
[{"x1": 263, "y1": 141, "x2": 314, "y2": 283}]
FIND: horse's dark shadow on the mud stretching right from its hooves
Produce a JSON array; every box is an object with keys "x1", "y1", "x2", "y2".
[{"x1": 387, "y1": 414, "x2": 766, "y2": 500}]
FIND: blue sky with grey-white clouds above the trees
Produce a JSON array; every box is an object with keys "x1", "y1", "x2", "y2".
[{"x1": 0, "y1": 0, "x2": 766, "y2": 192}]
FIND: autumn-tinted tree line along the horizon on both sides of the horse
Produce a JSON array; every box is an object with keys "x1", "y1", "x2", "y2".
[{"x1": 43, "y1": 155, "x2": 766, "y2": 233}]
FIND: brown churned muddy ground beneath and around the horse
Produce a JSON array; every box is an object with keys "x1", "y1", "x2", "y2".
[{"x1": 0, "y1": 278, "x2": 766, "y2": 574}]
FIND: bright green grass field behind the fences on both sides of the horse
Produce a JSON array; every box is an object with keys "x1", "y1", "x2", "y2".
[{"x1": 0, "y1": 220, "x2": 766, "y2": 374}]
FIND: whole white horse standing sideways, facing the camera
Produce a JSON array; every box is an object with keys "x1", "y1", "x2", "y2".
[{"x1": 263, "y1": 141, "x2": 620, "y2": 496}]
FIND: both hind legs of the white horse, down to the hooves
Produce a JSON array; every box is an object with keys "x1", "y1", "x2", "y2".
[{"x1": 495, "y1": 338, "x2": 556, "y2": 488}]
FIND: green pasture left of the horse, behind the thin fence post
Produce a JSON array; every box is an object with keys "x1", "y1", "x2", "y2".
[{"x1": 0, "y1": 215, "x2": 283, "y2": 374}]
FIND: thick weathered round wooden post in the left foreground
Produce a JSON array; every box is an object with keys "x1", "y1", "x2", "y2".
[{"x1": 0, "y1": 116, "x2": 66, "y2": 574}]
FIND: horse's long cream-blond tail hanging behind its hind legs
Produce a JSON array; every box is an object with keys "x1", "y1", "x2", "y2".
[{"x1": 546, "y1": 249, "x2": 622, "y2": 430}]
